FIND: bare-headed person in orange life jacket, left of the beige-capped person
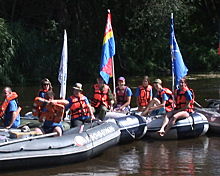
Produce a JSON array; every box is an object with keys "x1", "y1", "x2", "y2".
[{"x1": 135, "y1": 76, "x2": 153, "y2": 112}]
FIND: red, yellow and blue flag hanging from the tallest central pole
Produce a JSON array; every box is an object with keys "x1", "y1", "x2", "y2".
[{"x1": 100, "y1": 10, "x2": 115, "y2": 84}]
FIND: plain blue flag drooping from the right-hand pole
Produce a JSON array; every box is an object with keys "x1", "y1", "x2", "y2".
[{"x1": 170, "y1": 14, "x2": 188, "y2": 87}]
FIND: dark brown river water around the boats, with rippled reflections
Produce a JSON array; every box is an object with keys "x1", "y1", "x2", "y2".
[{"x1": 0, "y1": 74, "x2": 220, "y2": 176}]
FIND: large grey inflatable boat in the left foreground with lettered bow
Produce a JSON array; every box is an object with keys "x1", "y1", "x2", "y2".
[{"x1": 0, "y1": 120, "x2": 121, "y2": 171}]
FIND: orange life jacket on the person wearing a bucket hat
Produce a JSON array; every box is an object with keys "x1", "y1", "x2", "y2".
[{"x1": 70, "y1": 94, "x2": 90, "y2": 119}]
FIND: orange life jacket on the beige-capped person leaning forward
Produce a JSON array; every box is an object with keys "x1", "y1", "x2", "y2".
[{"x1": 157, "y1": 87, "x2": 173, "y2": 112}]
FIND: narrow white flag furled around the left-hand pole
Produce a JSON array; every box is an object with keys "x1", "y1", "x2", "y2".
[{"x1": 58, "y1": 30, "x2": 68, "y2": 99}]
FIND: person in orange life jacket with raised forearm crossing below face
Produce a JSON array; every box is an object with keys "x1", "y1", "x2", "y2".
[{"x1": 35, "y1": 91, "x2": 69, "y2": 136}]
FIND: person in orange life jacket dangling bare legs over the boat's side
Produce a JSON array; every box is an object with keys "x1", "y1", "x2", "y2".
[{"x1": 158, "y1": 78, "x2": 195, "y2": 136}]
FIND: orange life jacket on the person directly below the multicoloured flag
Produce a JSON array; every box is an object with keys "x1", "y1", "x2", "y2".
[{"x1": 91, "y1": 84, "x2": 109, "y2": 107}]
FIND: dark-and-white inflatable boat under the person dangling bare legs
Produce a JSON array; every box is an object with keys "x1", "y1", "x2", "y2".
[{"x1": 146, "y1": 112, "x2": 209, "y2": 139}]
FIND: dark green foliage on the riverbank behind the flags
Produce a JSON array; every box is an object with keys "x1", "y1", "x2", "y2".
[{"x1": 0, "y1": 0, "x2": 219, "y2": 84}]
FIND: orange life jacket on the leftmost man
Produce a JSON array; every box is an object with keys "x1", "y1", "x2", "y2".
[{"x1": 0, "y1": 92, "x2": 22, "y2": 118}]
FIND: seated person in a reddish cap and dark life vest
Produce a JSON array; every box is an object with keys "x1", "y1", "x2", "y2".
[{"x1": 114, "y1": 77, "x2": 133, "y2": 113}]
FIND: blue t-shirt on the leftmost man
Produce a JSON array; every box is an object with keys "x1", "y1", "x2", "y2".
[{"x1": 4, "y1": 100, "x2": 21, "y2": 128}]
